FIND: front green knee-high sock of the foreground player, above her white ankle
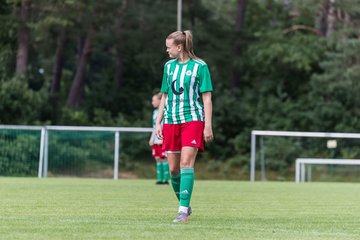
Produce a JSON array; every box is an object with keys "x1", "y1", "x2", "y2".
[{"x1": 180, "y1": 168, "x2": 194, "y2": 207}]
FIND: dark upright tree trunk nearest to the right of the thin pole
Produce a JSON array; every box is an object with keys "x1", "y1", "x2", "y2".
[{"x1": 232, "y1": 0, "x2": 246, "y2": 89}]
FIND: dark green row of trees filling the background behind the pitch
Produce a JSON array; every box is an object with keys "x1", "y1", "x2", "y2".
[{"x1": 0, "y1": 0, "x2": 360, "y2": 176}]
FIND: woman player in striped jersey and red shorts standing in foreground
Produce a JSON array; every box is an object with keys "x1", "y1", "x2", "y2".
[{"x1": 155, "y1": 31, "x2": 213, "y2": 222}]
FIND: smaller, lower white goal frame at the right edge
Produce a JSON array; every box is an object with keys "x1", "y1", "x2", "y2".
[{"x1": 295, "y1": 158, "x2": 360, "y2": 183}]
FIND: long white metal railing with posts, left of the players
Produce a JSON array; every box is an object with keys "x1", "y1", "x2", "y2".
[{"x1": 0, "y1": 125, "x2": 153, "y2": 180}]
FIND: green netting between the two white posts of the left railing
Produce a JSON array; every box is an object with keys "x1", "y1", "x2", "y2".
[{"x1": 48, "y1": 131, "x2": 114, "y2": 176}]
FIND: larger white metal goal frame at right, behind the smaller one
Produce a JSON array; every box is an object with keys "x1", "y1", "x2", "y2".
[{"x1": 250, "y1": 130, "x2": 360, "y2": 181}]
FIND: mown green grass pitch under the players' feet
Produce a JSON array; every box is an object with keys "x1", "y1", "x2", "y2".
[{"x1": 0, "y1": 178, "x2": 360, "y2": 240}]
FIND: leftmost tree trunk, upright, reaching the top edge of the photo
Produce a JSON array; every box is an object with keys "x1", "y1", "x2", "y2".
[{"x1": 16, "y1": 0, "x2": 31, "y2": 75}]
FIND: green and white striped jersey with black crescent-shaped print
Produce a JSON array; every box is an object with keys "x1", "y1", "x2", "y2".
[{"x1": 161, "y1": 59, "x2": 213, "y2": 124}]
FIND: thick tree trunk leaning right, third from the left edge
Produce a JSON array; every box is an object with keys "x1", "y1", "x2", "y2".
[{"x1": 66, "y1": 28, "x2": 94, "y2": 107}]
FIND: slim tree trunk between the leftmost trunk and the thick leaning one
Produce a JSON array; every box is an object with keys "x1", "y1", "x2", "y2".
[{"x1": 50, "y1": 29, "x2": 66, "y2": 98}]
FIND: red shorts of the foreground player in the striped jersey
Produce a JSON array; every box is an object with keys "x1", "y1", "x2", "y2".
[{"x1": 163, "y1": 121, "x2": 205, "y2": 152}]
